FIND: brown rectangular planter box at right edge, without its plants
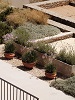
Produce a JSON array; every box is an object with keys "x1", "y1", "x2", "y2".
[{"x1": 53, "y1": 59, "x2": 75, "y2": 77}]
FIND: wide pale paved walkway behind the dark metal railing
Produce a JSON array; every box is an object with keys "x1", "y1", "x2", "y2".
[{"x1": 0, "y1": 60, "x2": 75, "y2": 100}]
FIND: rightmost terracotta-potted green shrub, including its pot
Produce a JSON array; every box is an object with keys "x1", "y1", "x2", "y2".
[{"x1": 45, "y1": 63, "x2": 56, "y2": 79}]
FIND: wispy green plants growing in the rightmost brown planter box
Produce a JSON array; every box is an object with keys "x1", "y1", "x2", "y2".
[{"x1": 56, "y1": 49, "x2": 75, "y2": 65}]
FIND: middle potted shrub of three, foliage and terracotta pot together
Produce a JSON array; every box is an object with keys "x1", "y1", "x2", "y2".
[{"x1": 22, "y1": 50, "x2": 37, "y2": 69}]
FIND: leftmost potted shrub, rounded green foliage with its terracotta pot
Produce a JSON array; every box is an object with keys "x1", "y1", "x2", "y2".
[{"x1": 4, "y1": 42, "x2": 15, "y2": 59}]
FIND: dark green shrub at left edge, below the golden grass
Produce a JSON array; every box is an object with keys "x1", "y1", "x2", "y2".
[{"x1": 0, "y1": 22, "x2": 12, "y2": 43}]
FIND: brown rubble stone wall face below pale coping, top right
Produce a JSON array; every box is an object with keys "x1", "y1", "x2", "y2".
[{"x1": 39, "y1": 0, "x2": 69, "y2": 9}]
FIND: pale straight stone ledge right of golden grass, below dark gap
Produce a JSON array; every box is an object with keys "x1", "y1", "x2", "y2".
[{"x1": 47, "y1": 19, "x2": 75, "y2": 33}]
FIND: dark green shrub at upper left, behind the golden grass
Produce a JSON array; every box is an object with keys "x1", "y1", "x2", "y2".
[{"x1": 0, "y1": 7, "x2": 13, "y2": 21}]
